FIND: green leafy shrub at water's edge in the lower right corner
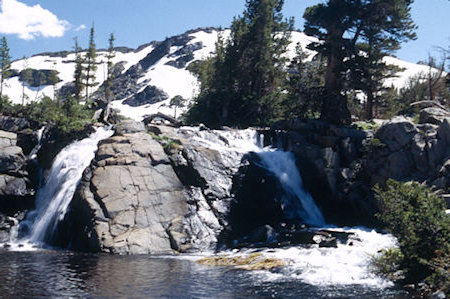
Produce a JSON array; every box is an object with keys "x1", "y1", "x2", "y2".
[{"x1": 375, "y1": 180, "x2": 450, "y2": 293}]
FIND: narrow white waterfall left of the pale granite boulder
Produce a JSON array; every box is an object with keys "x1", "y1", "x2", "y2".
[{"x1": 21, "y1": 128, "x2": 113, "y2": 244}]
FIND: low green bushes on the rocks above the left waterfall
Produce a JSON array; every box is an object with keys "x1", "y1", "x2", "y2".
[{"x1": 0, "y1": 96, "x2": 93, "y2": 134}]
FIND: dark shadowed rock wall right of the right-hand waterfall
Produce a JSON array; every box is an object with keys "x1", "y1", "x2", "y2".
[{"x1": 267, "y1": 116, "x2": 450, "y2": 225}]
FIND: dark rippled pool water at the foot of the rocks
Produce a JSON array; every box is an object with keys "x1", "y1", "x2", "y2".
[{"x1": 0, "y1": 250, "x2": 407, "y2": 298}]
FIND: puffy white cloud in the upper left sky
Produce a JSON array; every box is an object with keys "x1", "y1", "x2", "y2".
[{"x1": 0, "y1": 0, "x2": 69, "y2": 40}]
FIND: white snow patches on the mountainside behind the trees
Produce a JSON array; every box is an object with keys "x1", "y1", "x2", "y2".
[{"x1": 4, "y1": 29, "x2": 438, "y2": 120}]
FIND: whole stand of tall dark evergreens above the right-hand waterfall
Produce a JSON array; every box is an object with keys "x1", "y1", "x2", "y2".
[{"x1": 184, "y1": 0, "x2": 424, "y2": 127}]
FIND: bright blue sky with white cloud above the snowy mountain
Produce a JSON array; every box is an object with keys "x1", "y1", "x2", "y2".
[{"x1": 0, "y1": 0, "x2": 450, "y2": 62}]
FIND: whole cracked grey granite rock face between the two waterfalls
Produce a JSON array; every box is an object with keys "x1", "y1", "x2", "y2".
[{"x1": 67, "y1": 122, "x2": 255, "y2": 254}]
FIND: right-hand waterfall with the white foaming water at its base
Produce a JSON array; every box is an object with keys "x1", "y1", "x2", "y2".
[{"x1": 190, "y1": 129, "x2": 397, "y2": 289}]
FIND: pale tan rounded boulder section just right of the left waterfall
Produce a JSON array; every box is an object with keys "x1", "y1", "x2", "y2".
[{"x1": 72, "y1": 132, "x2": 187, "y2": 254}]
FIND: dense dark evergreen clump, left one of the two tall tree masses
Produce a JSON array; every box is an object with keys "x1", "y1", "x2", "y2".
[{"x1": 187, "y1": 0, "x2": 292, "y2": 126}]
